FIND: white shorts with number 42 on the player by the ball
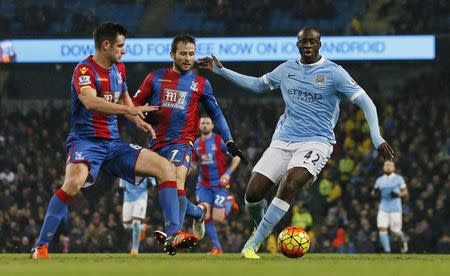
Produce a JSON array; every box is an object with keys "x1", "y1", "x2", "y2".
[{"x1": 252, "y1": 140, "x2": 333, "y2": 184}]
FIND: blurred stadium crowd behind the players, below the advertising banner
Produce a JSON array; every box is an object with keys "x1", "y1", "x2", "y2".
[{"x1": 0, "y1": 70, "x2": 450, "y2": 253}]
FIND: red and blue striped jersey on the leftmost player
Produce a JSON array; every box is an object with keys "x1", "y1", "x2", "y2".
[{"x1": 69, "y1": 56, "x2": 128, "y2": 139}]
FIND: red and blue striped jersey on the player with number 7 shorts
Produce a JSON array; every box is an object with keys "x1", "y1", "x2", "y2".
[{"x1": 133, "y1": 68, "x2": 232, "y2": 150}]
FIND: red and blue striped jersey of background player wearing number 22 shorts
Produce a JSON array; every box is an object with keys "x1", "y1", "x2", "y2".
[{"x1": 192, "y1": 133, "x2": 228, "y2": 187}]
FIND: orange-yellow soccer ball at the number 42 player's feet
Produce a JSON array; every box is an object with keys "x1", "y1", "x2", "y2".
[{"x1": 277, "y1": 226, "x2": 310, "y2": 258}]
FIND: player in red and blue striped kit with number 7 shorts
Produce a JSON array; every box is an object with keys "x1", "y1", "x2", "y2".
[{"x1": 133, "y1": 35, "x2": 248, "y2": 255}]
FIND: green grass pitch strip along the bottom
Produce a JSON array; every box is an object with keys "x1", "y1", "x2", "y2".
[{"x1": 0, "y1": 253, "x2": 450, "y2": 276}]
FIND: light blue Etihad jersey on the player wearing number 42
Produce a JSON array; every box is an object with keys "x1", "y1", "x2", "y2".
[{"x1": 262, "y1": 56, "x2": 365, "y2": 144}]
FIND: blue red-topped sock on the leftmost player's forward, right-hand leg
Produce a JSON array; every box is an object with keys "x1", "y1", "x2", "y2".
[{"x1": 158, "y1": 181, "x2": 181, "y2": 236}]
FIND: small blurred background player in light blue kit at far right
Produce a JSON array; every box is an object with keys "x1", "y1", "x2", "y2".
[{"x1": 372, "y1": 160, "x2": 408, "y2": 253}]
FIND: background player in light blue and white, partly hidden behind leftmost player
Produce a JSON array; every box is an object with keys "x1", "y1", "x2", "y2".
[{"x1": 119, "y1": 177, "x2": 156, "y2": 256}]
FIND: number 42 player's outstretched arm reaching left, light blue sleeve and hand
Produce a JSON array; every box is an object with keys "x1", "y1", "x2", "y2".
[{"x1": 197, "y1": 55, "x2": 270, "y2": 93}]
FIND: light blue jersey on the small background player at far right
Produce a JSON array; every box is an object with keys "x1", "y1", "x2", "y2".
[{"x1": 375, "y1": 173, "x2": 406, "y2": 213}]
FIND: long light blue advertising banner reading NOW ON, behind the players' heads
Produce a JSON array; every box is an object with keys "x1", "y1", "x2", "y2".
[{"x1": 0, "y1": 35, "x2": 435, "y2": 63}]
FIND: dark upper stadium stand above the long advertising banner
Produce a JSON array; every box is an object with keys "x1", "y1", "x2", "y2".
[{"x1": 0, "y1": 0, "x2": 450, "y2": 37}]
